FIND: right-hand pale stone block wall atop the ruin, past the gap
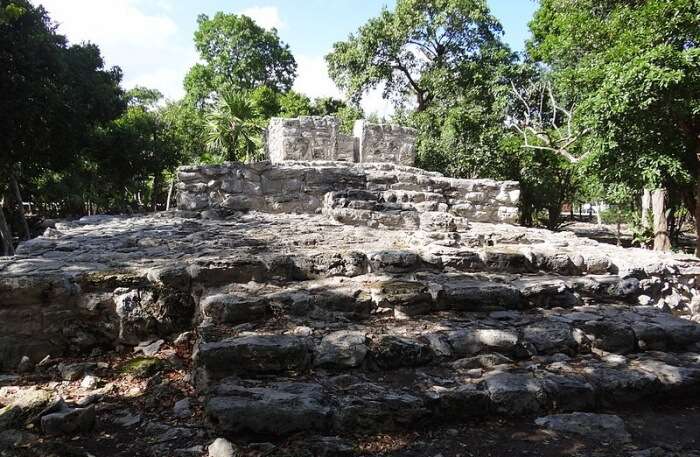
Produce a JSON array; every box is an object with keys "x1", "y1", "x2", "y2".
[{"x1": 353, "y1": 120, "x2": 416, "y2": 166}]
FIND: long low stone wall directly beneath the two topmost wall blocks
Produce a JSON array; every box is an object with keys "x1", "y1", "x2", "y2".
[{"x1": 177, "y1": 161, "x2": 520, "y2": 224}]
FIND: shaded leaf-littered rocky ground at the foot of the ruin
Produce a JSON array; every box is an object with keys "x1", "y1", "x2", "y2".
[{"x1": 0, "y1": 344, "x2": 700, "y2": 457}]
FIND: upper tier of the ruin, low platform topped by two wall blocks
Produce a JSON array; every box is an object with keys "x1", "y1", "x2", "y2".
[{"x1": 178, "y1": 116, "x2": 520, "y2": 224}]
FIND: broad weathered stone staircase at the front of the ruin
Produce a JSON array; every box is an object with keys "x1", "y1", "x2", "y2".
[{"x1": 185, "y1": 239, "x2": 700, "y2": 438}]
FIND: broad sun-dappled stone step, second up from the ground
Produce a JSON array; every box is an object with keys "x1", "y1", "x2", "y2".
[{"x1": 195, "y1": 305, "x2": 700, "y2": 387}]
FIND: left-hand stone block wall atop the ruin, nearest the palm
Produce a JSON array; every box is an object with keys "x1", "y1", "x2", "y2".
[{"x1": 266, "y1": 116, "x2": 355, "y2": 163}]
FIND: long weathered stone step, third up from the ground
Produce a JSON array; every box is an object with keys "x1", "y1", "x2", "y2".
[{"x1": 200, "y1": 270, "x2": 647, "y2": 325}]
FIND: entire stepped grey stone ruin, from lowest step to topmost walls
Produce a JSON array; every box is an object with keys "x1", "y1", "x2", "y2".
[{"x1": 0, "y1": 118, "x2": 700, "y2": 455}]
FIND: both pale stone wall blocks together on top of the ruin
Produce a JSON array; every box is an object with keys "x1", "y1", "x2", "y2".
[{"x1": 266, "y1": 116, "x2": 416, "y2": 166}]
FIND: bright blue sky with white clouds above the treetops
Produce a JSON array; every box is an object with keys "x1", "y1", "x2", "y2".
[{"x1": 33, "y1": 0, "x2": 537, "y2": 115}]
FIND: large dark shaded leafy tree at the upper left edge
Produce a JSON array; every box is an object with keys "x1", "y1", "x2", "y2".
[{"x1": 0, "y1": 0, "x2": 124, "y2": 253}]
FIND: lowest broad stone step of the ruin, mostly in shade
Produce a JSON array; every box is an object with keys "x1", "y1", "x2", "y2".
[{"x1": 205, "y1": 353, "x2": 700, "y2": 436}]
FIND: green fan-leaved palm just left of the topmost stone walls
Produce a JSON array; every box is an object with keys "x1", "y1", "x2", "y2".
[{"x1": 206, "y1": 89, "x2": 263, "y2": 162}]
